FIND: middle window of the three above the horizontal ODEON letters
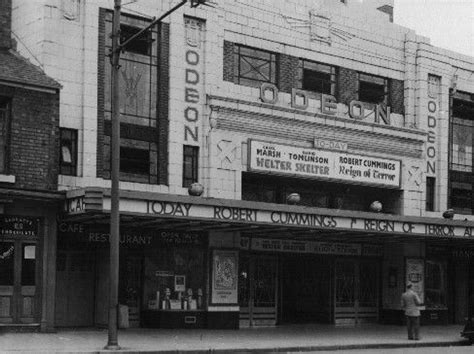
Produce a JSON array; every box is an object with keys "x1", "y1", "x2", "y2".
[{"x1": 298, "y1": 59, "x2": 336, "y2": 95}]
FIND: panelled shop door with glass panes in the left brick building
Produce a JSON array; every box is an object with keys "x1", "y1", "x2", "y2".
[{"x1": 0, "y1": 240, "x2": 37, "y2": 324}]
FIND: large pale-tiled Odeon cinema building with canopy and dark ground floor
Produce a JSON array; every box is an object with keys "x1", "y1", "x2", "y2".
[{"x1": 8, "y1": 0, "x2": 474, "y2": 328}]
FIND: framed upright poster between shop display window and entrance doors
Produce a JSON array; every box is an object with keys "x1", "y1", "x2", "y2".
[{"x1": 211, "y1": 250, "x2": 239, "y2": 304}]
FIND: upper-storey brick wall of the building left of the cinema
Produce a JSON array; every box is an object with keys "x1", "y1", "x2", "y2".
[{"x1": 9, "y1": 88, "x2": 59, "y2": 190}]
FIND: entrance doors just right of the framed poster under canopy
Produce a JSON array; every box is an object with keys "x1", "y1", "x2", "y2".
[{"x1": 239, "y1": 255, "x2": 277, "y2": 327}]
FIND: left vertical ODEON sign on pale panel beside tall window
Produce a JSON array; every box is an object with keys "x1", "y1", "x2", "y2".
[{"x1": 183, "y1": 17, "x2": 205, "y2": 145}]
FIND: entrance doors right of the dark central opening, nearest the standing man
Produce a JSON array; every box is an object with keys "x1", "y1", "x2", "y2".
[{"x1": 334, "y1": 259, "x2": 379, "y2": 325}]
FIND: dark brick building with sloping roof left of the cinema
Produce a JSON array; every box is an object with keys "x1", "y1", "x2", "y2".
[{"x1": 0, "y1": 1, "x2": 64, "y2": 330}]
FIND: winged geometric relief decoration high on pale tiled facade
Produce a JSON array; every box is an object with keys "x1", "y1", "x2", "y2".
[{"x1": 281, "y1": 10, "x2": 355, "y2": 45}]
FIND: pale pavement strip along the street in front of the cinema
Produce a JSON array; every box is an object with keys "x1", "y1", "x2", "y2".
[{"x1": 0, "y1": 324, "x2": 467, "y2": 354}]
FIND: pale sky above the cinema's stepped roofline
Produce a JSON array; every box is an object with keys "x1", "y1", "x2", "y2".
[{"x1": 394, "y1": 0, "x2": 474, "y2": 57}]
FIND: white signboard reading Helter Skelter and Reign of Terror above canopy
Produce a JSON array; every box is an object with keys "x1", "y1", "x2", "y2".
[{"x1": 249, "y1": 140, "x2": 401, "y2": 187}]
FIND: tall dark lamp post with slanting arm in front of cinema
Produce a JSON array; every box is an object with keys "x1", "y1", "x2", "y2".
[{"x1": 104, "y1": 0, "x2": 208, "y2": 350}]
